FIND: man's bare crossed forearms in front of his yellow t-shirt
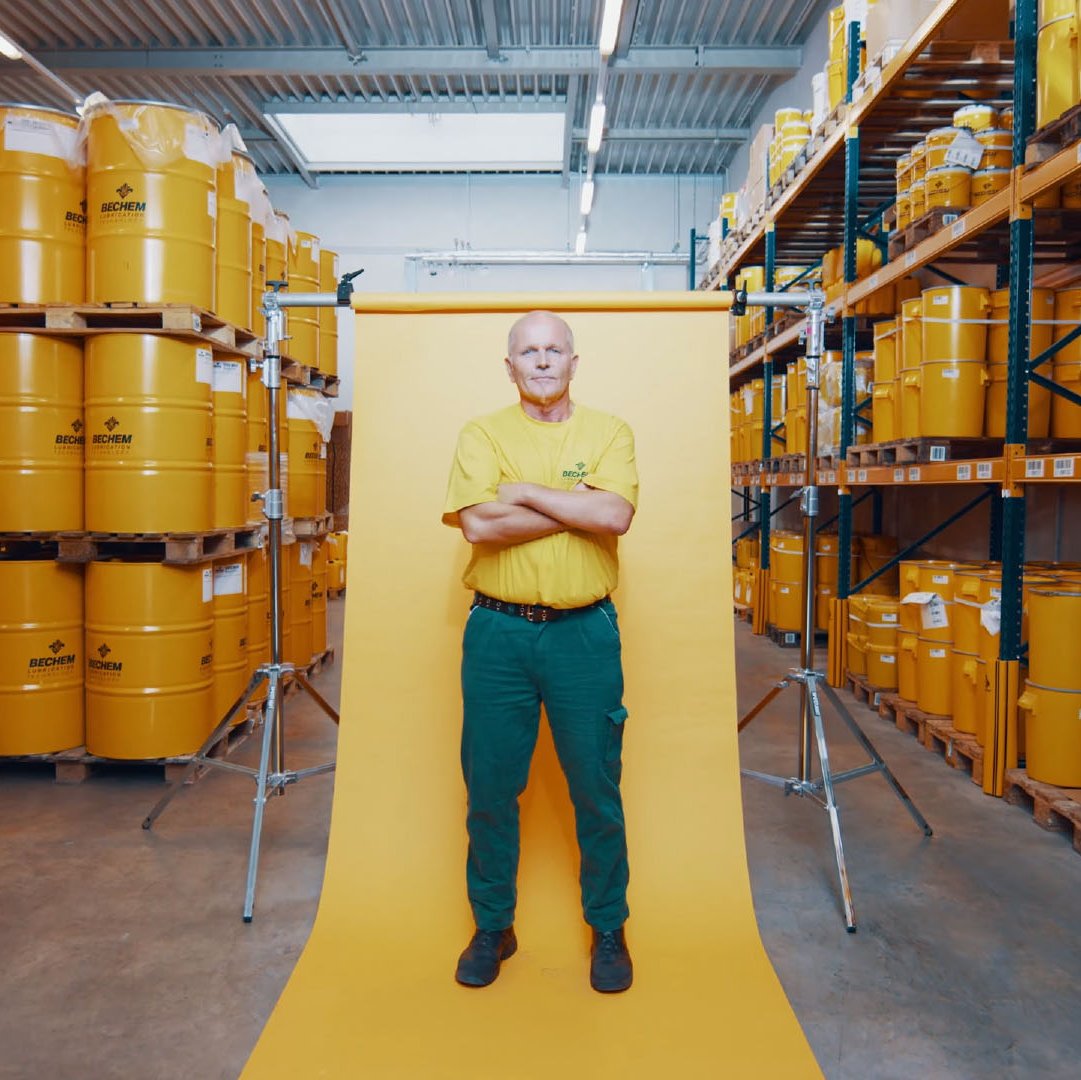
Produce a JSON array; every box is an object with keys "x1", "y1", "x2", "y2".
[{"x1": 458, "y1": 483, "x2": 635, "y2": 544}]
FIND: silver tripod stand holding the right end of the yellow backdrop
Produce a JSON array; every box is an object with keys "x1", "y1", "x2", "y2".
[{"x1": 733, "y1": 289, "x2": 932, "y2": 933}]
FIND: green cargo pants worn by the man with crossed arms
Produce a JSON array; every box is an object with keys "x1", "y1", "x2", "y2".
[{"x1": 462, "y1": 600, "x2": 627, "y2": 931}]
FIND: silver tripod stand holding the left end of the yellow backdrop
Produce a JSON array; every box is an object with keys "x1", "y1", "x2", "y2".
[{"x1": 143, "y1": 270, "x2": 363, "y2": 922}]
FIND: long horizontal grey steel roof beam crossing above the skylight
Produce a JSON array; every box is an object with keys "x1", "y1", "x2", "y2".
[{"x1": 31, "y1": 45, "x2": 803, "y2": 79}]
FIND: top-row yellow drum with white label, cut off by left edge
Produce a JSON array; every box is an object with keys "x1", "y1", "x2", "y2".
[{"x1": 0, "y1": 105, "x2": 86, "y2": 304}]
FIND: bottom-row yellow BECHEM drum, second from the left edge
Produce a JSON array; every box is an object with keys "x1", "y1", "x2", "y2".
[{"x1": 86, "y1": 562, "x2": 214, "y2": 758}]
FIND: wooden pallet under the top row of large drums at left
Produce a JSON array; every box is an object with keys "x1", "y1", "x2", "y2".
[{"x1": 0, "y1": 304, "x2": 263, "y2": 357}]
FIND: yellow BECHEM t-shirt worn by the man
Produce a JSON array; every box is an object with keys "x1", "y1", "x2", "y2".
[{"x1": 443, "y1": 404, "x2": 638, "y2": 608}]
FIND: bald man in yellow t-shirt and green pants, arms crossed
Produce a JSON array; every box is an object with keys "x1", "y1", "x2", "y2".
[{"x1": 443, "y1": 311, "x2": 638, "y2": 992}]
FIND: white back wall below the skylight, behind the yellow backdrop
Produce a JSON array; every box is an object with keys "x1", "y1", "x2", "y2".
[{"x1": 259, "y1": 175, "x2": 723, "y2": 409}]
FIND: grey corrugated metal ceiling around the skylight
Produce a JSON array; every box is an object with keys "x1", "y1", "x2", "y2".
[{"x1": 0, "y1": 0, "x2": 825, "y2": 174}]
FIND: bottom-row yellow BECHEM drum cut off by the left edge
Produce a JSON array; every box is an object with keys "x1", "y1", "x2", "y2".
[{"x1": 0, "y1": 560, "x2": 83, "y2": 755}]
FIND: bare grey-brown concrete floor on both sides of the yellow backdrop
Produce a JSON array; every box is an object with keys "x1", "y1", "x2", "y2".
[{"x1": 0, "y1": 602, "x2": 1081, "y2": 1080}]
